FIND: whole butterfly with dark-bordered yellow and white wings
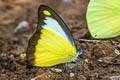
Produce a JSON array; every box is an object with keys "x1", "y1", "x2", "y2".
[{"x1": 26, "y1": 5, "x2": 82, "y2": 67}]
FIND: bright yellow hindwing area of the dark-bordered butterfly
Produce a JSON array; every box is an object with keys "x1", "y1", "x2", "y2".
[{"x1": 34, "y1": 29, "x2": 76, "y2": 67}]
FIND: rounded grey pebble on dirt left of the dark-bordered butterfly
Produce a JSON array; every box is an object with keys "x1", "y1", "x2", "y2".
[{"x1": 14, "y1": 21, "x2": 29, "y2": 34}]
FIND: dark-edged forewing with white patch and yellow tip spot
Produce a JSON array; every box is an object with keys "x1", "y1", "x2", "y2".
[{"x1": 38, "y1": 5, "x2": 76, "y2": 48}]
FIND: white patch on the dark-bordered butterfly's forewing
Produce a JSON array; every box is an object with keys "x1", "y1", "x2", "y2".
[{"x1": 42, "y1": 17, "x2": 75, "y2": 47}]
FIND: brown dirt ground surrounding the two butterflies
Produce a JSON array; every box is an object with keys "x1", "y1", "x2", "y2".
[{"x1": 0, "y1": 0, "x2": 120, "y2": 80}]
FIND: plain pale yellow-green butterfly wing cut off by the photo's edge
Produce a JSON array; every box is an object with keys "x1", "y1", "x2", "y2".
[{"x1": 87, "y1": 0, "x2": 120, "y2": 39}]
